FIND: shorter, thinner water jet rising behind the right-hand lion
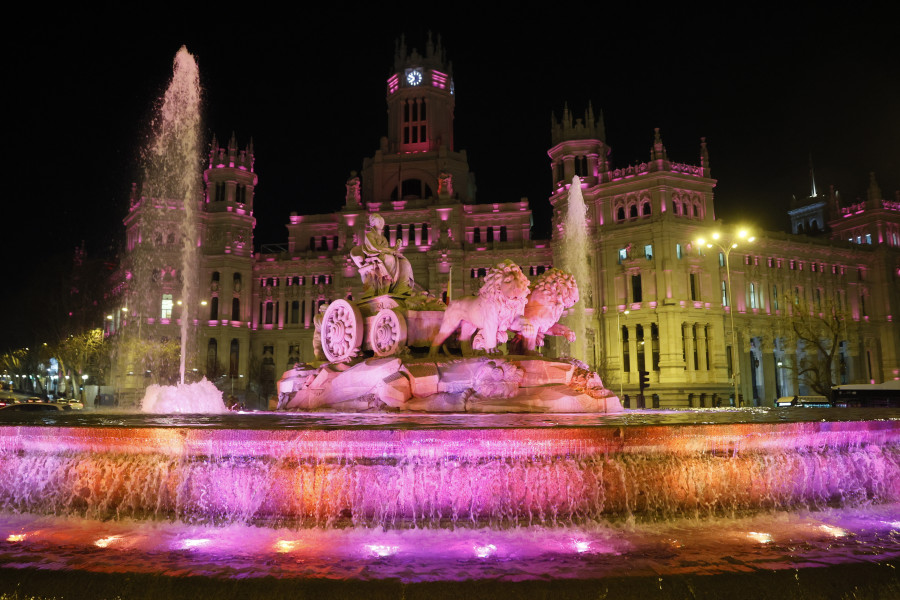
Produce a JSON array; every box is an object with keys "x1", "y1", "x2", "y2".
[{"x1": 562, "y1": 175, "x2": 591, "y2": 360}]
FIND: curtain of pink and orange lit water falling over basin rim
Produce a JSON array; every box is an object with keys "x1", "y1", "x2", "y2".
[{"x1": 0, "y1": 421, "x2": 900, "y2": 529}]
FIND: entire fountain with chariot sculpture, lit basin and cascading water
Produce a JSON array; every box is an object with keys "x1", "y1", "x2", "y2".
[{"x1": 0, "y1": 48, "x2": 900, "y2": 600}]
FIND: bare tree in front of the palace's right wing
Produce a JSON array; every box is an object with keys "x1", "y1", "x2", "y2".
[{"x1": 784, "y1": 296, "x2": 847, "y2": 400}]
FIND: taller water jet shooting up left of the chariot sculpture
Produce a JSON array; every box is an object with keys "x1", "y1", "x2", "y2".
[{"x1": 144, "y1": 46, "x2": 203, "y2": 383}]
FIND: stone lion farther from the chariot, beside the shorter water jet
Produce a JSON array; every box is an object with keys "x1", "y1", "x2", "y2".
[{"x1": 510, "y1": 269, "x2": 578, "y2": 354}]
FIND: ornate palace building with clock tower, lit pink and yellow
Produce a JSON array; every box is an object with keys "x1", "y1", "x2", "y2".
[{"x1": 110, "y1": 36, "x2": 900, "y2": 407}]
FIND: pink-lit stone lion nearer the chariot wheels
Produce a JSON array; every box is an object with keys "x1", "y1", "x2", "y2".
[{"x1": 429, "y1": 260, "x2": 528, "y2": 356}]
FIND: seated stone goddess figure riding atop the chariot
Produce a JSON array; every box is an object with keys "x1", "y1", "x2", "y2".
[{"x1": 350, "y1": 213, "x2": 414, "y2": 298}]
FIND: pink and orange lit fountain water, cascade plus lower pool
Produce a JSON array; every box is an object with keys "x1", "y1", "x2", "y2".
[{"x1": 0, "y1": 409, "x2": 900, "y2": 589}]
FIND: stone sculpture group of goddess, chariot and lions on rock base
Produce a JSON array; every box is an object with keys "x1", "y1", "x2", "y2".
[{"x1": 278, "y1": 213, "x2": 622, "y2": 413}]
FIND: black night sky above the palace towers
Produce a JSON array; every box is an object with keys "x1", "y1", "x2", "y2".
[{"x1": 0, "y1": 8, "x2": 900, "y2": 349}]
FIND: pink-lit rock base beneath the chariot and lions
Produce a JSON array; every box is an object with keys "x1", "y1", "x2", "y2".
[{"x1": 277, "y1": 356, "x2": 622, "y2": 413}]
